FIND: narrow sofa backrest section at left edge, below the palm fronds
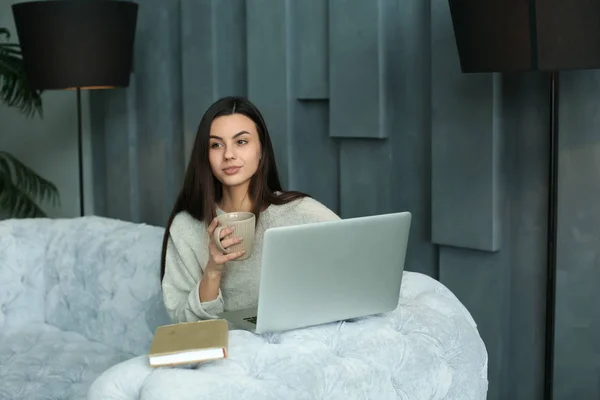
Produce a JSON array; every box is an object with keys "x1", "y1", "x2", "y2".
[{"x1": 0, "y1": 219, "x2": 52, "y2": 332}]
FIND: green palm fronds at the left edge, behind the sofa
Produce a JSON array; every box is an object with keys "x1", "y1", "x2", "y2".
[{"x1": 0, "y1": 27, "x2": 59, "y2": 218}]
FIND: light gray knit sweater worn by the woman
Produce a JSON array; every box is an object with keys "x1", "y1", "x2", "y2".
[{"x1": 162, "y1": 197, "x2": 339, "y2": 322}]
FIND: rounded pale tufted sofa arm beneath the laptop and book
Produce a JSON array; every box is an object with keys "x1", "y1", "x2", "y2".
[{"x1": 89, "y1": 272, "x2": 488, "y2": 400}]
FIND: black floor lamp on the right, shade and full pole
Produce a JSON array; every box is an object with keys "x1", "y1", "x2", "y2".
[{"x1": 449, "y1": 0, "x2": 600, "y2": 399}]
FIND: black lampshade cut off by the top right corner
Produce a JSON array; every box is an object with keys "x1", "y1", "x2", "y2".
[{"x1": 449, "y1": 0, "x2": 600, "y2": 72}]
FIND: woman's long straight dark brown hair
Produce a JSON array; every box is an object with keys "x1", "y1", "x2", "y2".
[{"x1": 160, "y1": 97, "x2": 308, "y2": 281}]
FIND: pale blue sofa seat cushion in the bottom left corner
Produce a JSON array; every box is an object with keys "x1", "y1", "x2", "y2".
[{"x1": 0, "y1": 323, "x2": 132, "y2": 400}]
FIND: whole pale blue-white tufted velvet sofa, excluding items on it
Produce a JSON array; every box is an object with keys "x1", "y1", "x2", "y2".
[{"x1": 0, "y1": 217, "x2": 488, "y2": 400}]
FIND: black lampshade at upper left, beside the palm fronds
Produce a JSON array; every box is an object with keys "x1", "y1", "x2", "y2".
[{"x1": 12, "y1": 0, "x2": 138, "y2": 90}]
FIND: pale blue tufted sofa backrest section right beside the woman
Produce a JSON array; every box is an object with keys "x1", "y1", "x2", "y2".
[{"x1": 45, "y1": 217, "x2": 168, "y2": 355}]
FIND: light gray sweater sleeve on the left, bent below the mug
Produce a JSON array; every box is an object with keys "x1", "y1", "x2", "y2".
[{"x1": 162, "y1": 212, "x2": 223, "y2": 323}]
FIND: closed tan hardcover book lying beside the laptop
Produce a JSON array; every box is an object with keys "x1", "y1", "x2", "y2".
[{"x1": 148, "y1": 319, "x2": 229, "y2": 367}]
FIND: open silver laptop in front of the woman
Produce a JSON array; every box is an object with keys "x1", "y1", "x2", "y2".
[{"x1": 220, "y1": 212, "x2": 411, "y2": 334}]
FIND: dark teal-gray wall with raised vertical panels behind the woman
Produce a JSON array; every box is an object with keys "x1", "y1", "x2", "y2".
[{"x1": 91, "y1": 0, "x2": 600, "y2": 400}]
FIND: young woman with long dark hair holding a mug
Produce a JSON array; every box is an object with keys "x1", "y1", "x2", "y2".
[{"x1": 161, "y1": 97, "x2": 339, "y2": 322}]
